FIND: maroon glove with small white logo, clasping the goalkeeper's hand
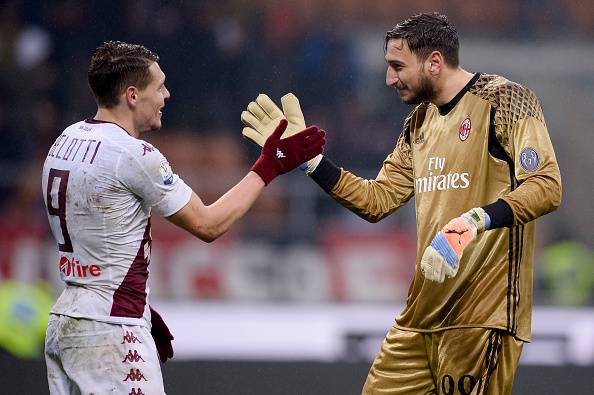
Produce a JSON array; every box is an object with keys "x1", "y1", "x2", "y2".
[{"x1": 252, "y1": 118, "x2": 326, "y2": 185}]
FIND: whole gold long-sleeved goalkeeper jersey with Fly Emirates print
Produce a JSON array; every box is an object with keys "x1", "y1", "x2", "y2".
[{"x1": 330, "y1": 73, "x2": 561, "y2": 341}]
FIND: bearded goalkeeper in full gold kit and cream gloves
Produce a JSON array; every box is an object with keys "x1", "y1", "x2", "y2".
[{"x1": 242, "y1": 14, "x2": 561, "y2": 395}]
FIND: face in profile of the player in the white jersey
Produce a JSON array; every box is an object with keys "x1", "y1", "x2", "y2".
[{"x1": 135, "y1": 62, "x2": 171, "y2": 132}]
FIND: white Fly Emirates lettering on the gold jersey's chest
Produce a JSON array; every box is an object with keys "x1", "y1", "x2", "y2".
[{"x1": 415, "y1": 156, "x2": 470, "y2": 194}]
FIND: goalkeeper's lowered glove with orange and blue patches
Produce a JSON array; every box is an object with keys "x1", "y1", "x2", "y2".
[{"x1": 421, "y1": 207, "x2": 491, "y2": 283}]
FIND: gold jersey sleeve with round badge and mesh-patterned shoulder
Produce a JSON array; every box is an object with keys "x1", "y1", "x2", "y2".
[{"x1": 496, "y1": 83, "x2": 562, "y2": 224}]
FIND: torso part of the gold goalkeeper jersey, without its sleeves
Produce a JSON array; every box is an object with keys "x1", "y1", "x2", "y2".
[{"x1": 397, "y1": 75, "x2": 534, "y2": 340}]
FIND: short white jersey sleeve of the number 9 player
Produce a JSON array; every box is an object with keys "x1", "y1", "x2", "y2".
[{"x1": 117, "y1": 143, "x2": 192, "y2": 217}]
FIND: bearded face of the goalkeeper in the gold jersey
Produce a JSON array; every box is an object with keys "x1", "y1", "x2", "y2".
[{"x1": 386, "y1": 39, "x2": 435, "y2": 104}]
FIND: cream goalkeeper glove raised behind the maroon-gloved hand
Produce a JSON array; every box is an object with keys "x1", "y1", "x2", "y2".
[{"x1": 241, "y1": 93, "x2": 322, "y2": 174}]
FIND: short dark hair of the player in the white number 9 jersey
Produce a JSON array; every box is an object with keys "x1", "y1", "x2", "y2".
[{"x1": 87, "y1": 41, "x2": 159, "y2": 108}]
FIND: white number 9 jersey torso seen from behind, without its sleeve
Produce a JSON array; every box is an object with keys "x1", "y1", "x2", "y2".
[{"x1": 42, "y1": 122, "x2": 150, "y2": 324}]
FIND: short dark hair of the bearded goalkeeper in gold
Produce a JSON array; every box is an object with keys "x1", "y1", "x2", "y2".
[{"x1": 384, "y1": 12, "x2": 460, "y2": 67}]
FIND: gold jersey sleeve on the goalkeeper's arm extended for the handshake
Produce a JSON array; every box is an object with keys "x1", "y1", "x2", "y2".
[{"x1": 330, "y1": 117, "x2": 414, "y2": 222}]
